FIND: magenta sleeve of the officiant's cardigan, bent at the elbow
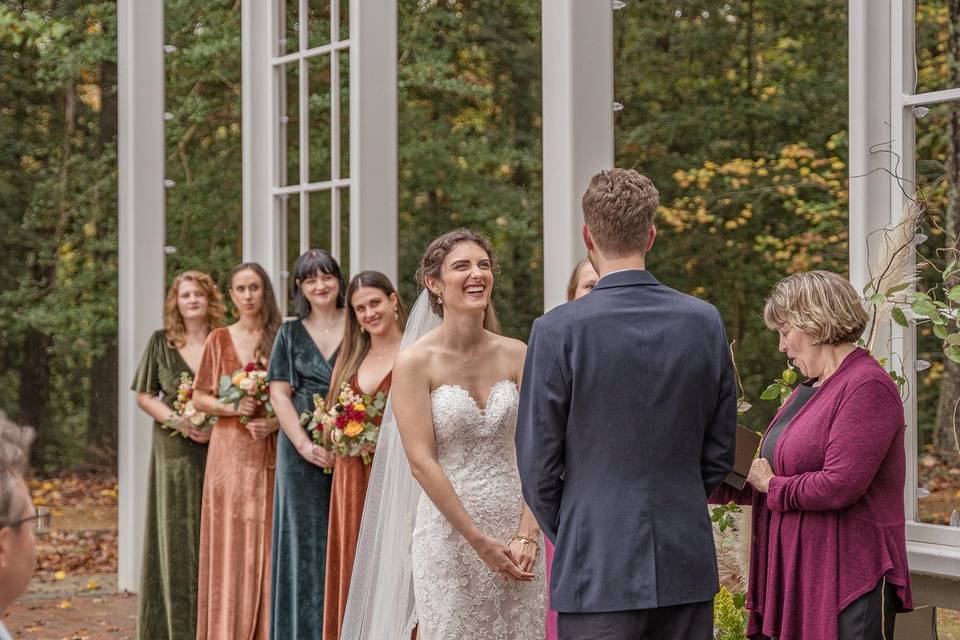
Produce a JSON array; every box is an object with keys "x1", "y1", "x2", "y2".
[{"x1": 766, "y1": 380, "x2": 903, "y2": 511}]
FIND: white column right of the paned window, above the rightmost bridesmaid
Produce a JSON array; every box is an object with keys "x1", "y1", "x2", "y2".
[{"x1": 348, "y1": 0, "x2": 397, "y2": 283}]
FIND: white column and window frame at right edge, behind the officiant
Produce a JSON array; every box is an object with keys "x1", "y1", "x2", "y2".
[{"x1": 849, "y1": 0, "x2": 960, "y2": 578}]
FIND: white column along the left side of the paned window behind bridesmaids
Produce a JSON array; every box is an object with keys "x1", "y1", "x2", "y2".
[{"x1": 241, "y1": 0, "x2": 286, "y2": 290}]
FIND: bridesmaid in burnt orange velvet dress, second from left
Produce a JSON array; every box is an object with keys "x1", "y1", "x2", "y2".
[{"x1": 193, "y1": 262, "x2": 281, "y2": 640}]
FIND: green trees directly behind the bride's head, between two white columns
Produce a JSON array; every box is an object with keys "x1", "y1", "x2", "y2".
[{"x1": 398, "y1": 0, "x2": 543, "y2": 338}]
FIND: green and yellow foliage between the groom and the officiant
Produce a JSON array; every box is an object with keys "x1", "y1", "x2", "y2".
[{"x1": 614, "y1": 0, "x2": 847, "y2": 427}]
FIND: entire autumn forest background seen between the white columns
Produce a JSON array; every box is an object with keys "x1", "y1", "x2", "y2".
[{"x1": 0, "y1": 0, "x2": 960, "y2": 469}]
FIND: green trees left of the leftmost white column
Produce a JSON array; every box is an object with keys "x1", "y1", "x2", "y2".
[{"x1": 0, "y1": 1, "x2": 117, "y2": 463}]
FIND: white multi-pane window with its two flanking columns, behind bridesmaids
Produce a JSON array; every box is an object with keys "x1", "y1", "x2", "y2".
[{"x1": 248, "y1": 0, "x2": 398, "y2": 310}]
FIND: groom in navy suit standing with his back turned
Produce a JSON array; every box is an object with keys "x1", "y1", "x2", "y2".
[{"x1": 517, "y1": 169, "x2": 737, "y2": 640}]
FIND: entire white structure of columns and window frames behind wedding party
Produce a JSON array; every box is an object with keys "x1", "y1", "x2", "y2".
[{"x1": 118, "y1": 0, "x2": 960, "y2": 608}]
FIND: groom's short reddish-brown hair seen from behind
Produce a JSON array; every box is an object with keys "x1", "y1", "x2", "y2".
[{"x1": 583, "y1": 169, "x2": 660, "y2": 256}]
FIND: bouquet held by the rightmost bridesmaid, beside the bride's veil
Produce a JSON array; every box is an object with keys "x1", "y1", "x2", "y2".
[{"x1": 301, "y1": 382, "x2": 387, "y2": 464}]
